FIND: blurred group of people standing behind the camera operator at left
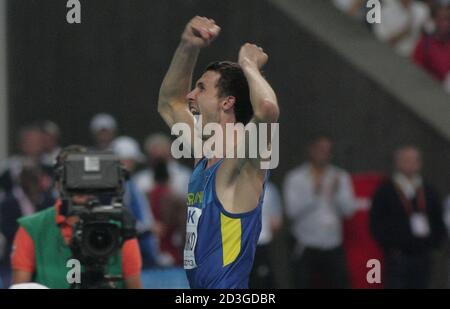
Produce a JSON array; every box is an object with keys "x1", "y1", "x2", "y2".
[{"x1": 0, "y1": 113, "x2": 191, "y2": 288}]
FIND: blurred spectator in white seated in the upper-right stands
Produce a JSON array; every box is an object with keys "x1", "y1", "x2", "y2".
[{"x1": 373, "y1": 0, "x2": 431, "y2": 57}]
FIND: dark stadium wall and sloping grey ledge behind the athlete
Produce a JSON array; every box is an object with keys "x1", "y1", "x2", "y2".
[{"x1": 2, "y1": 0, "x2": 450, "y2": 286}]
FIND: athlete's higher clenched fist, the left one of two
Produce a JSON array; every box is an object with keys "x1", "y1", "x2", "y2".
[{"x1": 181, "y1": 16, "x2": 220, "y2": 47}]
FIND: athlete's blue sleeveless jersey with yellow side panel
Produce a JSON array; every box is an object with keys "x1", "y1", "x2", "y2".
[{"x1": 184, "y1": 158, "x2": 267, "y2": 289}]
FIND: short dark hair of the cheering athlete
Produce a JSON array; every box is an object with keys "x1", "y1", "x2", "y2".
[{"x1": 205, "y1": 61, "x2": 253, "y2": 125}]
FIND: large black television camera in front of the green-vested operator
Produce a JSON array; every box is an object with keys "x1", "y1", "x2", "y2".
[{"x1": 58, "y1": 152, "x2": 136, "y2": 288}]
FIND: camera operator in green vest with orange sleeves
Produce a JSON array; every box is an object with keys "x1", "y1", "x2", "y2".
[{"x1": 11, "y1": 146, "x2": 142, "y2": 289}]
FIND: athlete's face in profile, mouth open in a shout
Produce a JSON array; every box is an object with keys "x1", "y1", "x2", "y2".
[{"x1": 186, "y1": 71, "x2": 223, "y2": 127}]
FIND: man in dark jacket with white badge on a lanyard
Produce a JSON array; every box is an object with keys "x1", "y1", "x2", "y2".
[{"x1": 370, "y1": 146, "x2": 445, "y2": 288}]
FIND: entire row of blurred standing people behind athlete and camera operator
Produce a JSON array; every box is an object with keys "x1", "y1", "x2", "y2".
[{"x1": 0, "y1": 114, "x2": 450, "y2": 288}]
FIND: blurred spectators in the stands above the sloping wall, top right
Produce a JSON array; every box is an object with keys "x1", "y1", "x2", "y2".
[{"x1": 332, "y1": 0, "x2": 450, "y2": 93}]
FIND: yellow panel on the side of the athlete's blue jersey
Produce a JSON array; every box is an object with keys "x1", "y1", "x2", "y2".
[{"x1": 220, "y1": 213, "x2": 242, "y2": 267}]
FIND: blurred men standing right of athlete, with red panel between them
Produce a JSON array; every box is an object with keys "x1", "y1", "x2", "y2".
[{"x1": 283, "y1": 137, "x2": 450, "y2": 288}]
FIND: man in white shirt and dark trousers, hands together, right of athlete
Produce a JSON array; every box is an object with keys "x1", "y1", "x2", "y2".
[{"x1": 283, "y1": 137, "x2": 356, "y2": 288}]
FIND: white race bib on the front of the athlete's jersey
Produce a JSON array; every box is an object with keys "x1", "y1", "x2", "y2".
[{"x1": 184, "y1": 207, "x2": 202, "y2": 269}]
